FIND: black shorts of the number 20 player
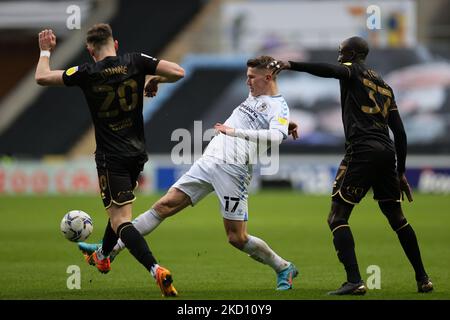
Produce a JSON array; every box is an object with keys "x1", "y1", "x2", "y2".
[{"x1": 95, "y1": 153, "x2": 147, "y2": 209}]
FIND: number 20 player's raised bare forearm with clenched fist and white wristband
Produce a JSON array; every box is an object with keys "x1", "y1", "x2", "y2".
[{"x1": 34, "y1": 29, "x2": 64, "y2": 86}]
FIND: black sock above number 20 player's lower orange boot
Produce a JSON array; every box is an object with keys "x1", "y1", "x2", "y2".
[{"x1": 117, "y1": 222, "x2": 157, "y2": 272}]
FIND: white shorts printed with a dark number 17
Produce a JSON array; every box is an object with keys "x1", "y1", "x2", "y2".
[{"x1": 172, "y1": 156, "x2": 252, "y2": 221}]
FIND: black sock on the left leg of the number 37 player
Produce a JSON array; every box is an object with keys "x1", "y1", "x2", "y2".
[{"x1": 332, "y1": 224, "x2": 361, "y2": 283}]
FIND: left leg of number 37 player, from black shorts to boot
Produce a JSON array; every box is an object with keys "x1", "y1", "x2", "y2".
[{"x1": 327, "y1": 159, "x2": 369, "y2": 295}]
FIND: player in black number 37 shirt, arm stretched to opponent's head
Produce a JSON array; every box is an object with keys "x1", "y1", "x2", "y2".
[{"x1": 273, "y1": 37, "x2": 433, "y2": 295}]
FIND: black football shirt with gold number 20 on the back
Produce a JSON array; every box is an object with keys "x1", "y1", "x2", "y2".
[{"x1": 63, "y1": 53, "x2": 159, "y2": 157}]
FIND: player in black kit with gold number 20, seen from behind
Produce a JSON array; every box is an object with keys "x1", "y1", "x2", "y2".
[{"x1": 35, "y1": 24, "x2": 184, "y2": 296}]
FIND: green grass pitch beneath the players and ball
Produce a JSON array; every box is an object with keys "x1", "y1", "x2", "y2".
[{"x1": 0, "y1": 191, "x2": 450, "y2": 300}]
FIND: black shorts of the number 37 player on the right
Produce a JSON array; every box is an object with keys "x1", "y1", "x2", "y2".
[{"x1": 332, "y1": 144, "x2": 401, "y2": 204}]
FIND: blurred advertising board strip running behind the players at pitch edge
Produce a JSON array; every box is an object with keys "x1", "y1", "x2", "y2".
[{"x1": 0, "y1": 156, "x2": 450, "y2": 195}]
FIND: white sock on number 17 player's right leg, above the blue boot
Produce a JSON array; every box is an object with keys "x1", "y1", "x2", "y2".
[{"x1": 242, "y1": 235, "x2": 289, "y2": 273}]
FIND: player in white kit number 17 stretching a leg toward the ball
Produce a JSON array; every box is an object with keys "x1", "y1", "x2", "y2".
[{"x1": 79, "y1": 56, "x2": 298, "y2": 290}]
